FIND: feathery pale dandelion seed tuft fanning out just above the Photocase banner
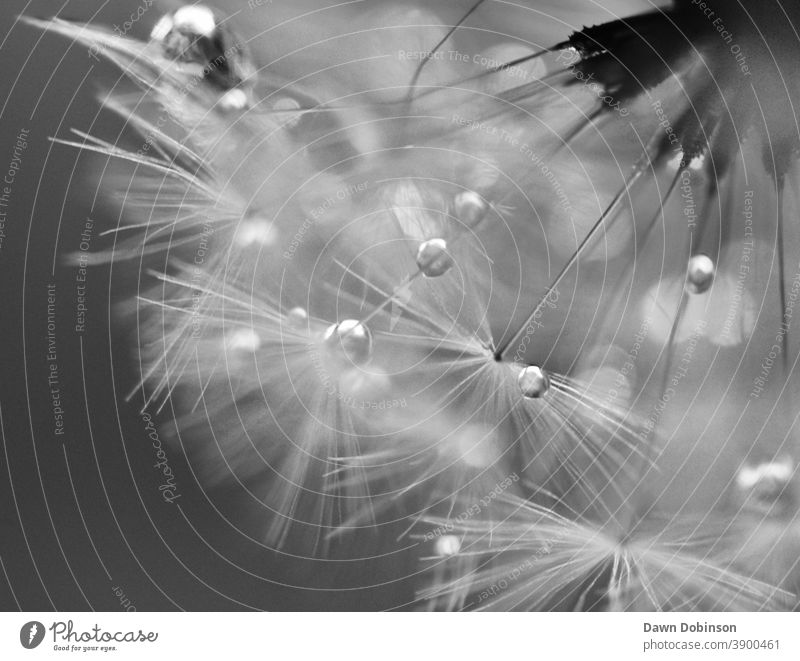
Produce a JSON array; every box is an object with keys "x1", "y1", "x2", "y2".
[{"x1": 422, "y1": 497, "x2": 788, "y2": 611}]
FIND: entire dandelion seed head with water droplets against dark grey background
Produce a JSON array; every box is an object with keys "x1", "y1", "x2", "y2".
[{"x1": 10, "y1": 0, "x2": 800, "y2": 611}]
